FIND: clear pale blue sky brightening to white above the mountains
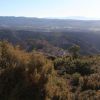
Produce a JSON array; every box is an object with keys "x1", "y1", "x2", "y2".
[{"x1": 0, "y1": 0, "x2": 100, "y2": 18}]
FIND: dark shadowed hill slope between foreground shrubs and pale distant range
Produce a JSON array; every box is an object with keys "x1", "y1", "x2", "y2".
[{"x1": 0, "y1": 29, "x2": 100, "y2": 55}]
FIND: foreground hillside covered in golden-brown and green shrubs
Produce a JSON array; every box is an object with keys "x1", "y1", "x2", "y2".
[{"x1": 0, "y1": 41, "x2": 100, "y2": 100}]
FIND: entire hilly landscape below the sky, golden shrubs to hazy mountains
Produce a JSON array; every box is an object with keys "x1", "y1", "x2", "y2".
[{"x1": 0, "y1": 17, "x2": 100, "y2": 100}]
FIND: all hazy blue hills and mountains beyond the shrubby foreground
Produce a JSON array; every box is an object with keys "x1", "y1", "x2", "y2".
[{"x1": 0, "y1": 17, "x2": 100, "y2": 56}]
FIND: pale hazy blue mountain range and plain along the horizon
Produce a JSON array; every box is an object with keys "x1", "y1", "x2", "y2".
[{"x1": 0, "y1": 17, "x2": 100, "y2": 31}]
